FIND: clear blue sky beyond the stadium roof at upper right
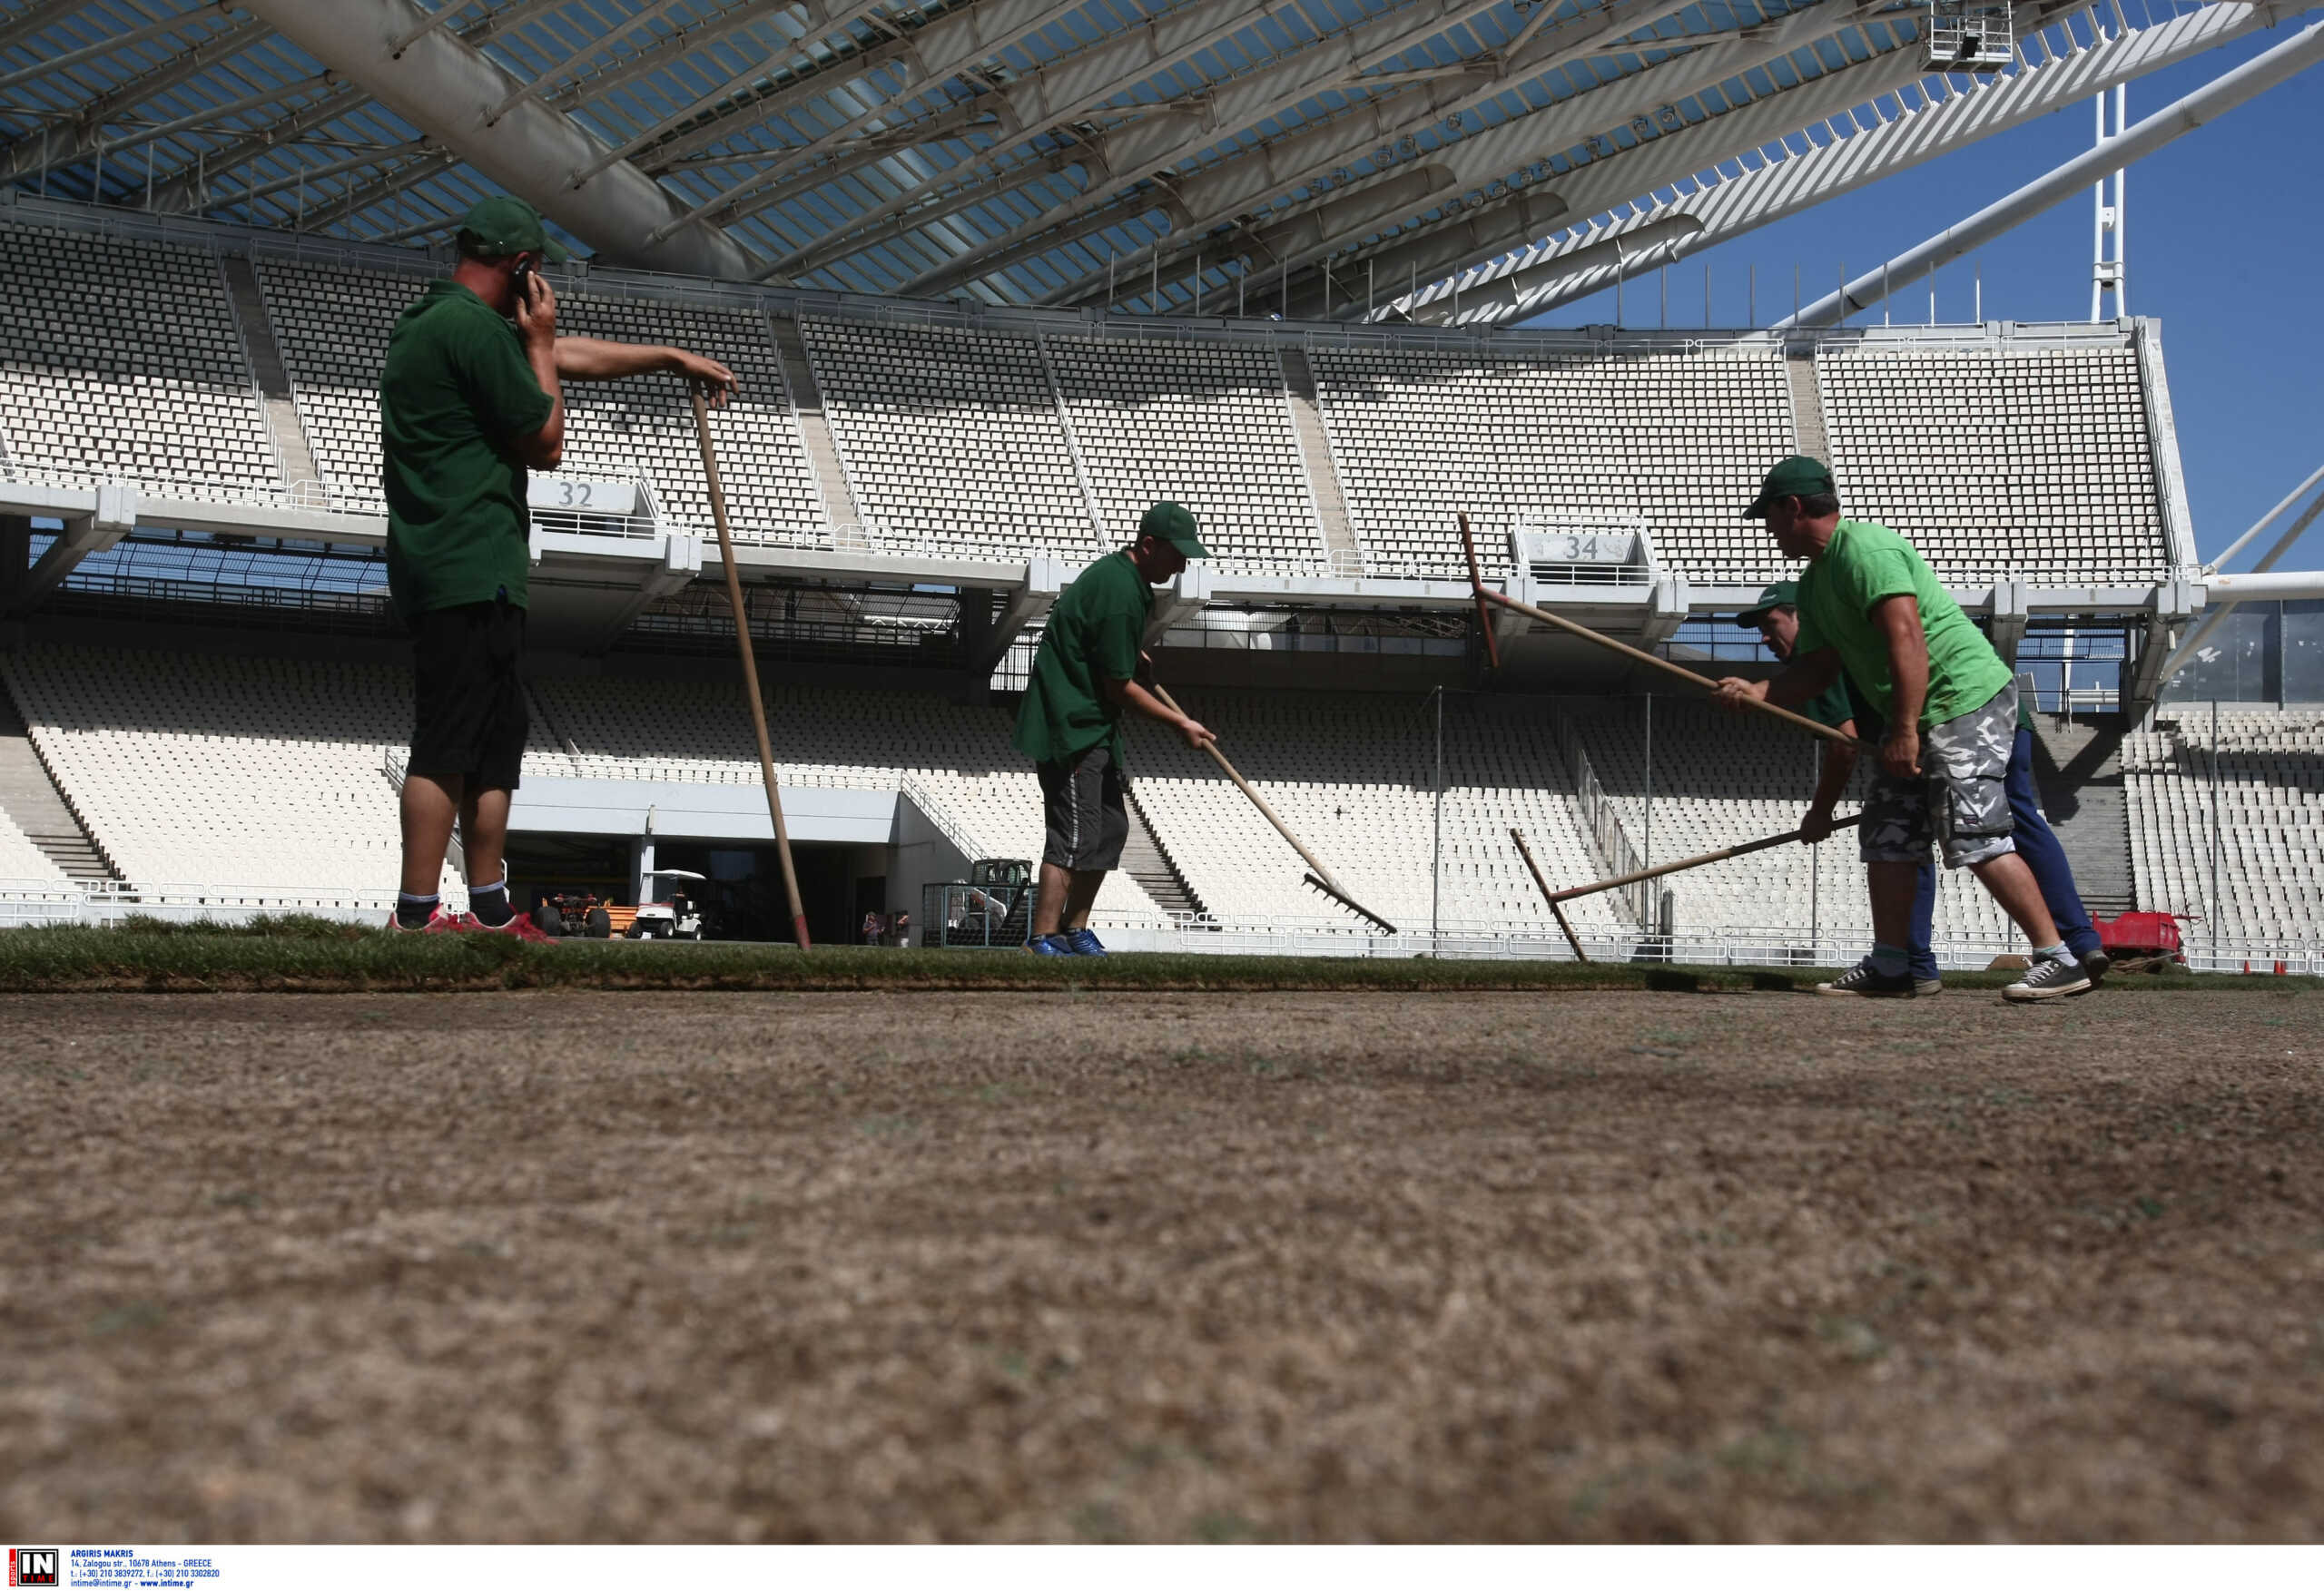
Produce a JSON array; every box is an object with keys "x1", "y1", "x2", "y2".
[{"x1": 1541, "y1": 12, "x2": 2324, "y2": 569}]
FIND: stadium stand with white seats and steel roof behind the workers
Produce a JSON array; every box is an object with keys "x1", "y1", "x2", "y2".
[{"x1": 0, "y1": 0, "x2": 2324, "y2": 967}]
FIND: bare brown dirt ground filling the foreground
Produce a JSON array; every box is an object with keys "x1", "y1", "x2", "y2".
[{"x1": 0, "y1": 992, "x2": 2324, "y2": 1542}]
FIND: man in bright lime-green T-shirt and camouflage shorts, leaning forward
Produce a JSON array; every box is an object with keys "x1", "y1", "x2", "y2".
[{"x1": 1718, "y1": 456, "x2": 2092, "y2": 1001}]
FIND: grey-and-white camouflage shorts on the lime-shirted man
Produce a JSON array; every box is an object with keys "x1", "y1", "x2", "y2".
[{"x1": 1856, "y1": 681, "x2": 2017, "y2": 867}]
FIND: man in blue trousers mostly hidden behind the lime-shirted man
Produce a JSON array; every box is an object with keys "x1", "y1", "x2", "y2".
[{"x1": 1736, "y1": 581, "x2": 2108, "y2": 998}]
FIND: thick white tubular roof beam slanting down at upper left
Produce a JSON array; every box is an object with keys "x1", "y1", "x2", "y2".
[{"x1": 244, "y1": 0, "x2": 755, "y2": 279}]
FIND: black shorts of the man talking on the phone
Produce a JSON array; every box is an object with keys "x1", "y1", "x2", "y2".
[{"x1": 404, "y1": 602, "x2": 532, "y2": 790}]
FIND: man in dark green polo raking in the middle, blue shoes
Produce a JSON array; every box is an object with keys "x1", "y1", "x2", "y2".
[{"x1": 1016, "y1": 502, "x2": 1217, "y2": 955}]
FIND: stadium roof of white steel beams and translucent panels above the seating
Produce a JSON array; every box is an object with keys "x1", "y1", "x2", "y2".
[{"x1": 0, "y1": 0, "x2": 2306, "y2": 325}]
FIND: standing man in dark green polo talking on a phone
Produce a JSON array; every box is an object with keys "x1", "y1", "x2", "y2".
[{"x1": 379, "y1": 198, "x2": 734, "y2": 938}]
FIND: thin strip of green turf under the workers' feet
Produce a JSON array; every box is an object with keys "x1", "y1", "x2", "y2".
[{"x1": 0, "y1": 918, "x2": 2296, "y2": 994}]
